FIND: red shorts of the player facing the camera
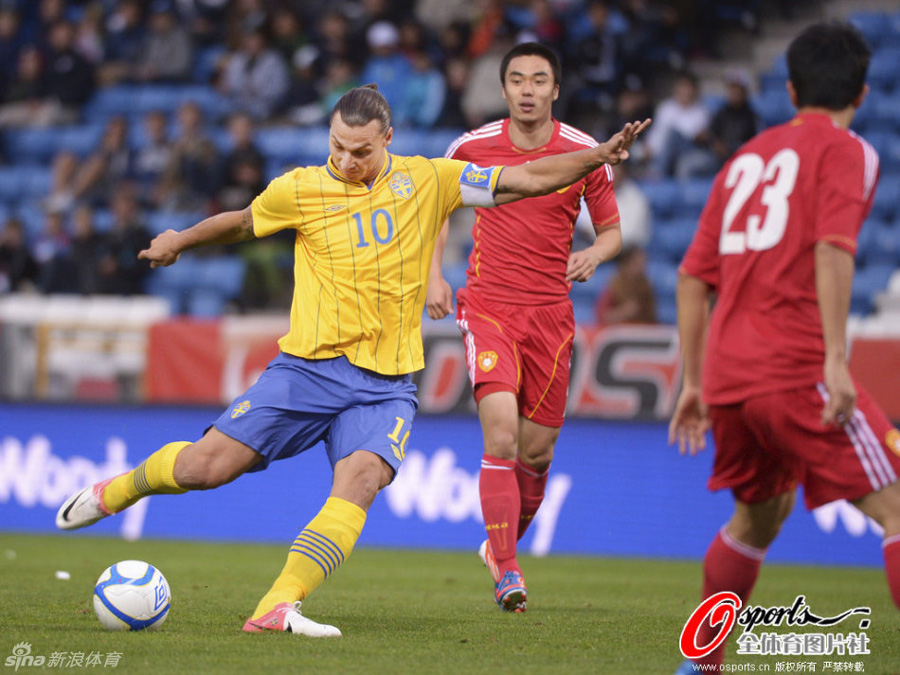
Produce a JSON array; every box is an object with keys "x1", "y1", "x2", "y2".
[{"x1": 456, "y1": 289, "x2": 575, "y2": 427}]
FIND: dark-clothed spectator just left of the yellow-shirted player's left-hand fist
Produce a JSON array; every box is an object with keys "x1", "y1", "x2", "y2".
[{"x1": 98, "y1": 189, "x2": 152, "y2": 295}]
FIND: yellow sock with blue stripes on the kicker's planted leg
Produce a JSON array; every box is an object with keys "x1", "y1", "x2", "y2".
[{"x1": 252, "y1": 497, "x2": 366, "y2": 619}]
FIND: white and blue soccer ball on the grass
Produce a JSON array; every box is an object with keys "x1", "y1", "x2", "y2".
[{"x1": 94, "y1": 560, "x2": 170, "y2": 630}]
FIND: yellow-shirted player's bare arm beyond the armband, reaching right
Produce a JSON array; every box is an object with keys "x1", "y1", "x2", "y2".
[{"x1": 494, "y1": 118, "x2": 650, "y2": 205}]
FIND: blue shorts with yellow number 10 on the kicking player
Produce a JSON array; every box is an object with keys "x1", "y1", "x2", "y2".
[{"x1": 214, "y1": 352, "x2": 418, "y2": 476}]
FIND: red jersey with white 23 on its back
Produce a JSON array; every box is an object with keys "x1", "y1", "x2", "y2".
[{"x1": 681, "y1": 114, "x2": 878, "y2": 405}]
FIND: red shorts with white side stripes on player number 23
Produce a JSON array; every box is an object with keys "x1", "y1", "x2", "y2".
[{"x1": 709, "y1": 383, "x2": 900, "y2": 509}]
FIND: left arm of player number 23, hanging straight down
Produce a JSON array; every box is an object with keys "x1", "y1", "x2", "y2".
[{"x1": 669, "y1": 274, "x2": 709, "y2": 455}]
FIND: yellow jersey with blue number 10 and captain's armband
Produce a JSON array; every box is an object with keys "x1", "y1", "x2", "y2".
[{"x1": 251, "y1": 154, "x2": 501, "y2": 375}]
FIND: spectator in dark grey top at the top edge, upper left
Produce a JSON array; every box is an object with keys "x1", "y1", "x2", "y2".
[{"x1": 133, "y1": 0, "x2": 194, "y2": 82}]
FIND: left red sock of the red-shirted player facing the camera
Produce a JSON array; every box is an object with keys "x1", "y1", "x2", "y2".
[{"x1": 478, "y1": 454, "x2": 519, "y2": 575}]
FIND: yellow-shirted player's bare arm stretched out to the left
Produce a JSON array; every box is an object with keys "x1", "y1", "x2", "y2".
[{"x1": 138, "y1": 206, "x2": 255, "y2": 268}]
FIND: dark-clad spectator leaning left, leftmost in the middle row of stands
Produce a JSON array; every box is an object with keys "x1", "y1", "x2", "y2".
[{"x1": 48, "y1": 117, "x2": 135, "y2": 211}]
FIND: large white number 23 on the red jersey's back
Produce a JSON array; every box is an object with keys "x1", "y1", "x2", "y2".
[{"x1": 719, "y1": 148, "x2": 800, "y2": 255}]
